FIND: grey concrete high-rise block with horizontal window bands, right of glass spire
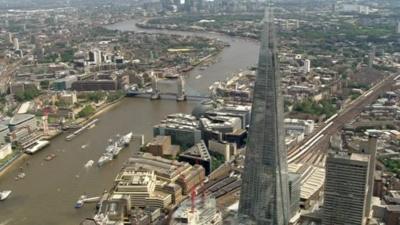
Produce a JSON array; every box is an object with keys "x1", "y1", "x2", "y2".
[{"x1": 322, "y1": 151, "x2": 370, "y2": 225}]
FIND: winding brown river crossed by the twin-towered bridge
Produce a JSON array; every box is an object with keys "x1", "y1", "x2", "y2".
[{"x1": 0, "y1": 20, "x2": 258, "y2": 225}]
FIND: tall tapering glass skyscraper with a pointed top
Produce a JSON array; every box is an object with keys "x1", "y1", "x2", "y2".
[{"x1": 239, "y1": 4, "x2": 289, "y2": 225}]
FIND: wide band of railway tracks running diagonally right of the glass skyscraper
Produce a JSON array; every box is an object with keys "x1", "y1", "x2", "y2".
[{"x1": 288, "y1": 75, "x2": 398, "y2": 166}]
